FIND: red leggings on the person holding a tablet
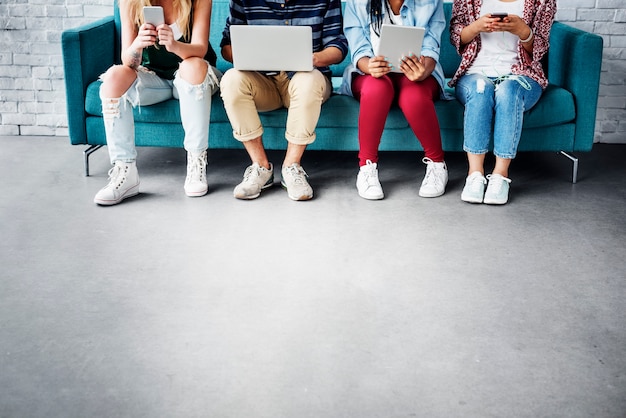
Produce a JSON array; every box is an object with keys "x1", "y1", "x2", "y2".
[{"x1": 352, "y1": 73, "x2": 443, "y2": 166}]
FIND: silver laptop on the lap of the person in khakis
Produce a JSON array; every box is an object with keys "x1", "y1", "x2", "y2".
[{"x1": 230, "y1": 25, "x2": 313, "y2": 71}]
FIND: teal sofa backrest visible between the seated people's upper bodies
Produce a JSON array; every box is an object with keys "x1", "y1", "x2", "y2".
[{"x1": 115, "y1": 0, "x2": 461, "y2": 77}]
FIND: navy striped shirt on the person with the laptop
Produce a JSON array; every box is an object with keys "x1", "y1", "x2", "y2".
[{"x1": 220, "y1": 0, "x2": 348, "y2": 76}]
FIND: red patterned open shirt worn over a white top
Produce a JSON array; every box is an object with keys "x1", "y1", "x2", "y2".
[{"x1": 448, "y1": 0, "x2": 556, "y2": 89}]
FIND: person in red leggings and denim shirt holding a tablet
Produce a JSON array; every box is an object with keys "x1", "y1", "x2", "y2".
[{"x1": 341, "y1": 0, "x2": 448, "y2": 200}]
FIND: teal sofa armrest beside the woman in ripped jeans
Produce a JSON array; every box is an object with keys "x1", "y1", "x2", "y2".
[{"x1": 61, "y1": 16, "x2": 116, "y2": 145}]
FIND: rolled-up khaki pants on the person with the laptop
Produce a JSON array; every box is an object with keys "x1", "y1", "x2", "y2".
[{"x1": 220, "y1": 69, "x2": 332, "y2": 145}]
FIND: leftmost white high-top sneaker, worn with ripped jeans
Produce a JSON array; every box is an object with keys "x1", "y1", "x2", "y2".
[{"x1": 93, "y1": 161, "x2": 139, "y2": 206}]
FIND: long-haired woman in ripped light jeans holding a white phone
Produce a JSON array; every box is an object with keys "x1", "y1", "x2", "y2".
[{"x1": 94, "y1": 0, "x2": 219, "y2": 205}]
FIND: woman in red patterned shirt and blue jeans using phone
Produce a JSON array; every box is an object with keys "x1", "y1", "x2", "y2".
[{"x1": 449, "y1": 0, "x2": 556, "y2": 205}]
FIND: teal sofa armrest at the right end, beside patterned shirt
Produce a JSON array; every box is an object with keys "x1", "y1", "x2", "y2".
[{"x1": 547, "y1": 22, "x2": 602, "y2": 151}]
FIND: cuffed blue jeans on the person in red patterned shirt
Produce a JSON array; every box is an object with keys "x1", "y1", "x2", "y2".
[{"x1": 455, "y1": 74, "x2": 543, "y2": 159}]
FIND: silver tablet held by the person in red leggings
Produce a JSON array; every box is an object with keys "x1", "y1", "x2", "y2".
[{"x1": 375, "y1": 24, "x2": 426, "y2": 72}]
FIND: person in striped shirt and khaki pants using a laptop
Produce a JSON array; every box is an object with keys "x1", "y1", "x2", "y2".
[{"x1": 220, "y1": 0, "x2": 348, "y2": 200}]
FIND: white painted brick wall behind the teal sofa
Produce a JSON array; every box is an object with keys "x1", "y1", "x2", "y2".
[{"x1": 0, "y1": 0, "x2": 626, "y2": 143}]
